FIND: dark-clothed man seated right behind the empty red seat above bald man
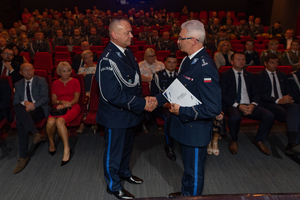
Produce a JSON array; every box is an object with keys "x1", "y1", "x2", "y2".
[{"x1": 29, "y1": 31, "x2": 51, "y2": 58}]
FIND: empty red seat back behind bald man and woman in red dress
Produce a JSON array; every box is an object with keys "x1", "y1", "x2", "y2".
[{"x1": 33, "y1": 52, "x2": 53, "y2": 73}]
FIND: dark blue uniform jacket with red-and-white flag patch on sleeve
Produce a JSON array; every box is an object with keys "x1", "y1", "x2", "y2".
[{"x1": 156, "y1": 48, "x2": 222, "y2": 147}]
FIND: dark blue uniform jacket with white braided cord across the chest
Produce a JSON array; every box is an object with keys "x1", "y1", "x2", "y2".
[{"x1": 95, "y1": 42, "x2": 146, "y2": 128}]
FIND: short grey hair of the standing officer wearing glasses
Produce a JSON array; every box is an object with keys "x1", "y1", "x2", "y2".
[{"x1": 181, "y1": 20, "x2": 205, "y2": 44}]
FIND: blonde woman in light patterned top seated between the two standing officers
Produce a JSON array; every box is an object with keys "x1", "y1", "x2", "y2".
[{"x1": 139, "y1": 48, "x2": 165, "y2": 83}]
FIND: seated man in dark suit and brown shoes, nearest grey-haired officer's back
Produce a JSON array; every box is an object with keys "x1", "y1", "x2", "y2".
[{"x1": 220, "y1": 52, "x2": 274, "y2": 155}]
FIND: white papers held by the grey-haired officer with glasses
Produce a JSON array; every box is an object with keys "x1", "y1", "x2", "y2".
[{"x1": 163, "y1": 79, "x2": 202, "y2": 107}]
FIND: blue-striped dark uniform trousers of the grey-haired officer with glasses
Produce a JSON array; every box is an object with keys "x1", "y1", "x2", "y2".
[{"x1": 181, "y1": 144, "x2": 207, "y2": 196}]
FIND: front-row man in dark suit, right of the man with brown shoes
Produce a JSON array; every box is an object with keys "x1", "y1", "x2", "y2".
[{"x1": 256, "y1": 54, "x2": 300, "y2": 154}]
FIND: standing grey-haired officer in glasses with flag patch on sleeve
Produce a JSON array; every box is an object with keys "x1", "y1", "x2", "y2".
[{"x1": 155, "y1": 20, "x2": 222, "y2": 197}]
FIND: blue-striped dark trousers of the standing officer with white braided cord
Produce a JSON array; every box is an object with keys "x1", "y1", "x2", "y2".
[{"x1": 103, "y1": 128, "x2": 134, "y2": 191}]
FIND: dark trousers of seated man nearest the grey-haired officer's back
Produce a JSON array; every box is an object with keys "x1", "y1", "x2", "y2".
[{"x1": 226, "y1": 106, "x2": 274, "y2": 142}]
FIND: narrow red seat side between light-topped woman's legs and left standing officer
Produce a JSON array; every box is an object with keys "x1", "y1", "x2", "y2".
[{"x1": 84, "y1": 76, "x2": 100, "y2": 124}]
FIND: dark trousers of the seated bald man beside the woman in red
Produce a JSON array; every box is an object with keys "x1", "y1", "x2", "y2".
[{"x1": 14, "y1": 104, "x2": 45, "y2": 158}]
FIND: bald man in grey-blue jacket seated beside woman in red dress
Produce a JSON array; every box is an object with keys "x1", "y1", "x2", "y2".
[{"x1": 13, "y1": 63, "x2": 49, "y2": 174}]
